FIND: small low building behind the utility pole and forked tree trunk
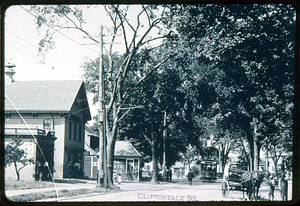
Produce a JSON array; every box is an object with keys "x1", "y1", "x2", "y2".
[{"x1": 84, "y1": 127, "x2": 142, "y2": 181}]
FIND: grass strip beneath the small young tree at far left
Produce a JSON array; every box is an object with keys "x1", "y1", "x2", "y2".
[{"x1": 5, "y1": 178, "x2": 53, "y2": 190}]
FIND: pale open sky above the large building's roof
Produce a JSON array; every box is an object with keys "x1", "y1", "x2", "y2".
[{"x1": 4, "y1": 5, "x2": 149, "y2": 122}]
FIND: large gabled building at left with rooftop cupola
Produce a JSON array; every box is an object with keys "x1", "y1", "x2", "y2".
[{"x1": 5, "y1": 68, "x2": 91, "y2": 178}]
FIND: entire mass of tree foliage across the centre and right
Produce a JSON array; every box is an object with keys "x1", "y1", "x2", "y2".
[{"x1": 33, "y1": 4, "x2": 295, "y2": 180}]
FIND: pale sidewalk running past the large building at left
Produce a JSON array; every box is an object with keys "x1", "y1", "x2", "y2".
[{"x1": 5, "y1": 179, "x2": 97, "y2": 198}]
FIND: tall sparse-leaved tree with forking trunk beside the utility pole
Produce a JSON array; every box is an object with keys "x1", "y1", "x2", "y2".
[{"x1": 32, "y1": 5, "x2": 169, "y2": 186}]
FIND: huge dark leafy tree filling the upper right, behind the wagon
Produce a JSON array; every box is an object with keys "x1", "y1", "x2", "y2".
[{"x1": 163, "y1": 4, "x2": 295, "y2": 169}]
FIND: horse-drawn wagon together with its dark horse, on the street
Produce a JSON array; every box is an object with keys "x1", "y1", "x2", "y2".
[{"x1": 221, "y1": 169, "x2": 265, "y2": 200}]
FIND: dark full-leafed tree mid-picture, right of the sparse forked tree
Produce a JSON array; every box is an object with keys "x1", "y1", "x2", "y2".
[{"x1": 122, "y1": 45, "x2": 188, "y2": 184}]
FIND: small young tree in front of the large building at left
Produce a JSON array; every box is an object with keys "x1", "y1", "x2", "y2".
[{"x1": 5, "y1": 136, "x2": 34, "y2": 180}]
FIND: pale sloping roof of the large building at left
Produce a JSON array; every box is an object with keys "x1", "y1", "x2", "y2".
[{"x1": 5, "y1": 80, "x2": 90, "y2": 116}]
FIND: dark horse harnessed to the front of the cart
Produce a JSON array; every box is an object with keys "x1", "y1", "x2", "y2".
[{"x1": 242, "y1": 171, "x2": 265, "y2": 200}]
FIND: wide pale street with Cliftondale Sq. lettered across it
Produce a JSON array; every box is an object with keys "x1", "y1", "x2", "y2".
[{"x1": 46, "y1": 179, "x2": 292, "y2": 202}]
